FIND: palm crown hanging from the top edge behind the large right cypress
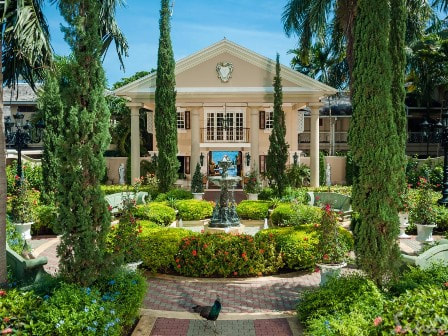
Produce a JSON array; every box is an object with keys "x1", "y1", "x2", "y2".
[{"x1": 282, "y1": 0, "x2": 438, "y2": 89}]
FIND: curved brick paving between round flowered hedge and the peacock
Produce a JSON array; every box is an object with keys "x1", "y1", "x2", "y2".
[{"x1": 143, "y1": 273, "x2": 320, "y2": 313}]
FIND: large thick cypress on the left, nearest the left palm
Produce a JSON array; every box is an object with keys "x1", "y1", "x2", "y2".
[{"x1": 57, "y1": 0, "x2": 110, "y2": 285}]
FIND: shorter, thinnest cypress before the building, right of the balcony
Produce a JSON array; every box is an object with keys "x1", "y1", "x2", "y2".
[{"x1": 266, "y1": 54, "x2": 289, "y2": 197}]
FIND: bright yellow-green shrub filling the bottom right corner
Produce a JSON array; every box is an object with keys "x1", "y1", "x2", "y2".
[{"x1": 378, "y1": 286, "x2": 448, "y2": 335}]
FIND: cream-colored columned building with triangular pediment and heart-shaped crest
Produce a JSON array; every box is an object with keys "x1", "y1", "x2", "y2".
[{"x1": 114, "y1": 39, "x2": 337, "y2": 186}]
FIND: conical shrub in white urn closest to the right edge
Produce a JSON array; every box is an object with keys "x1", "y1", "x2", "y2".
[{"x1": 410, "y1": 177, "x2": 436, "y2": 242}]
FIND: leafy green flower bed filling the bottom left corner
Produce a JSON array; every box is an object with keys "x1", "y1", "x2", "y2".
[{"x1": 0, "y1": 271, "x2": 146, "y2": 336}]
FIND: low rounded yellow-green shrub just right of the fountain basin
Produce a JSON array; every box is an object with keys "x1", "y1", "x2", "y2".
[{"x1": 271, "y1": 203, "x2": 322, "y2": 226}]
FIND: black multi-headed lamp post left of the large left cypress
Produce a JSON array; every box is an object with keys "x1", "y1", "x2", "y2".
[{"x1": 5, "y1": 112, "x2": 45, "y2": 186}]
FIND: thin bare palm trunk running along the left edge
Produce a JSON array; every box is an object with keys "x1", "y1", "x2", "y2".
[{"x1": 0, "y1": 47, "x2": 8, "y2": 284}]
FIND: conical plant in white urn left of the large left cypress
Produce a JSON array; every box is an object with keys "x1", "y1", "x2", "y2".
[{"x1": 10, "y1": 176, "x2": 37, "y2": 240}]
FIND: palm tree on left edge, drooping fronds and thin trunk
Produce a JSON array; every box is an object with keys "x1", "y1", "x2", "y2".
[{"x1": 0, "y1": 0, "x2": 52, "y2": 283}]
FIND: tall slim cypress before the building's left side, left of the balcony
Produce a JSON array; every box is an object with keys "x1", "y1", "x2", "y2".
[{"x1": 154, "y1": 0, "x2": 179, "y2": 192}]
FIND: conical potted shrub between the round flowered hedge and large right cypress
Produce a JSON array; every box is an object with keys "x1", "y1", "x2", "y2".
[{"x1": 317, "y1": 204, "x2": 349, "y2": 285}]
